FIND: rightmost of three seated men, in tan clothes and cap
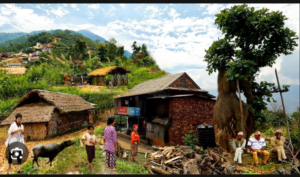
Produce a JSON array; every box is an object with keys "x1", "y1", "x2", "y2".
[{"x1": 271, "y1": 129, "x2": 288, "y2": 163}]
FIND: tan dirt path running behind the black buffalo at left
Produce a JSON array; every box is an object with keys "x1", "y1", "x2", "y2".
[{"x1": 0, "y1": 122, "x2": 106, "y2": 174}]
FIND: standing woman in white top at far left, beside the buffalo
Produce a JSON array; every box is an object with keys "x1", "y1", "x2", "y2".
[{"x1": 5, "y1": 113, "x2": 25, "y2": 173}]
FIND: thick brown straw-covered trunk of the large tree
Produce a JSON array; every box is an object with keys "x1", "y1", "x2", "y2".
[{"x1": 213, "y1": 69, "x2": 254, "y2": 152}]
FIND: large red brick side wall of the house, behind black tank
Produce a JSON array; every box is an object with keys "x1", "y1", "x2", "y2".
[{"x1": 169, "y1": 97, "x2": 215, "y2": 146}]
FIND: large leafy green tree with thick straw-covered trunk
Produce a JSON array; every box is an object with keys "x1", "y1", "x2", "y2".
[{"x1": 204, "y1": 4, "x2": 298, "y2": 150}]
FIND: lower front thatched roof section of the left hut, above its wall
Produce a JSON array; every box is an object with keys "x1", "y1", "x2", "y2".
[{"x1": 1, "y1": 103, "x2": 55, "y2": 125}]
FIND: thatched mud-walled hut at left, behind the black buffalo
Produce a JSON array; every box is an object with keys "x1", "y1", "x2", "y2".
[{"x1": 1, "y1": 90, "x2": 95, "y2": 140}]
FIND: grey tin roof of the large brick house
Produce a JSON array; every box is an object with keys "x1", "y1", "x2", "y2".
[{"x1": 116, "y1": 72, "x2": 215, "y2": 98}]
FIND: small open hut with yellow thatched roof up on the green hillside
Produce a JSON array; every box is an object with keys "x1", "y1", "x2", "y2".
[{"x1": 88, "y1": 66, "x2": 131, "y2": 86}]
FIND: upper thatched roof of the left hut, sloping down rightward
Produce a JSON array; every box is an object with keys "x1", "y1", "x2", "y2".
[{"x1": 14, "y1": 89, "x2": 95, "y2": 114}]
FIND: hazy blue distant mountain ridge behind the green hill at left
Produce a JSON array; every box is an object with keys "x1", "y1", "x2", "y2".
[{"x1": 0, "y1": 29, "x2": 131, "y2": 58}]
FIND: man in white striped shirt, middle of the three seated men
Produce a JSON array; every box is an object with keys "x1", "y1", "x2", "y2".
[{"x1": 248, "y1": 131, "x2": 270, "y2": 166}]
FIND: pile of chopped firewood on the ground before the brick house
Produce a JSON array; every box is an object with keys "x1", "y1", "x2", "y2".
[{"x1": 143, "y1": 146, "x2": 238, "y2": 175}]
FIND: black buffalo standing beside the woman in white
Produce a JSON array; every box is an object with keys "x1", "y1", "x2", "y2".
[{"x1": 32, "y1": 140, "x2": 75, "y2": 168}]
